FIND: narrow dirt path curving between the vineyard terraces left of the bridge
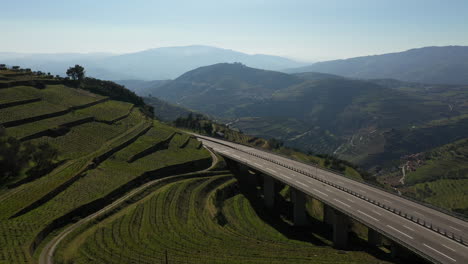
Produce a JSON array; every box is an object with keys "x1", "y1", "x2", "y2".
[{"x1": 39, "y1": 144, "x2": 218, "y2": 264}]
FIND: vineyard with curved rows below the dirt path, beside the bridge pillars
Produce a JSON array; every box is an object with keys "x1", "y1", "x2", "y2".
[{"x1": 57, "y1": 174, "x2": 394, "y2": 264}]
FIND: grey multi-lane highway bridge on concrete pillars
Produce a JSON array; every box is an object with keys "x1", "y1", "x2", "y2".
[{"x1": 196, "y1": 135, "x2": 468, "y2": 264}]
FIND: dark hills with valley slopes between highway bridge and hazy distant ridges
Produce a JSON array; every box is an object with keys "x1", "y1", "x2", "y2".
[{"x1": 153, "y1": 64, "x2": 468, "y2": 168}]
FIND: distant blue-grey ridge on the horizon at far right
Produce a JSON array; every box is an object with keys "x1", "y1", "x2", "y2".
[{"x1": 285, "y1": 46, "x2": 468, "y2": 84}]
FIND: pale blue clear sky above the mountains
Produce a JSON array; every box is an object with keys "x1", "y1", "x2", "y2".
[{"x1": 0, "y1": 0, "x2": 468, "y2": 61}]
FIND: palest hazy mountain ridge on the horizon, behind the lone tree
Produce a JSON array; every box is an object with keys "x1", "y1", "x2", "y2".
[{"x1": 0, "y1": 45, "x2": 305, "y2": 80}]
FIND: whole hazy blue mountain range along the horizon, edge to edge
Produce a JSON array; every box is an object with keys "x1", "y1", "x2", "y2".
[{"x1": 4, "y1": 45, "x2": 468, "y2": 84}]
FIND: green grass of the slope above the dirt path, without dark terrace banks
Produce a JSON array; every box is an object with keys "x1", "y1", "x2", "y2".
[{"x1": 0, "y1": 69, "x2": 210, "y2": 263}]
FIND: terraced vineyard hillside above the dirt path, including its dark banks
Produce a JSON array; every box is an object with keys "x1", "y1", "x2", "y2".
[{"x1": 0, "y1": 71, "x2": 211, "y2": 263}]
